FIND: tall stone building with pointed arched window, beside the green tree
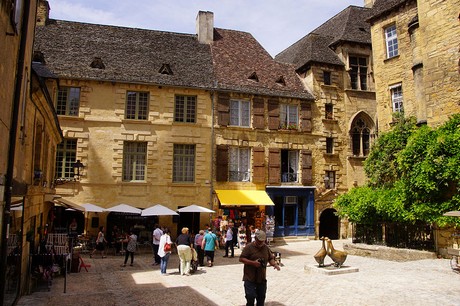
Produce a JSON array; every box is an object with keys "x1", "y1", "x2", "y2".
[{"x1": 275, "y1": 6, "x2": 377, "y2": 238}]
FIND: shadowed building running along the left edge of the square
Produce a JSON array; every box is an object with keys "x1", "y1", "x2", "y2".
[{"x1": 0, "y1": 1, "x2": 62, "y2": 305}]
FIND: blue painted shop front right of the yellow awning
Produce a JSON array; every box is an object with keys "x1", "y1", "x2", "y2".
[{"x1": 265, "y1": 186, "x2": 315, "y2": 237}]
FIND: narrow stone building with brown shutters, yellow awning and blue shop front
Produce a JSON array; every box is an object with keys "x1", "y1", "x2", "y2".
[{"x1": 197, "y1": 12, "x2": 321, "y2": 236}]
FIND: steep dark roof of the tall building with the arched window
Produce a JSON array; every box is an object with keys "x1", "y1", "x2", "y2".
[{"x1": 275, "y1": 6, "x2": 371, "y2": 69}]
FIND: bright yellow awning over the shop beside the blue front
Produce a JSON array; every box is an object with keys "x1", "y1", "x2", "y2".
[{"x1": 216, "y1": 190, "x2": 275, "y2": 206}]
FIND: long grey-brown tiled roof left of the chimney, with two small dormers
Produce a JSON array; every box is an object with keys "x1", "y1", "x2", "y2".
[{"x1": 34, "y1": 20, "x2": 213, "y2": 88}]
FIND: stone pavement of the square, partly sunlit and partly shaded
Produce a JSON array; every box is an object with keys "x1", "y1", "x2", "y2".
[{"x1": 18, "y1": 240, "x2": 460, "y2": 306}]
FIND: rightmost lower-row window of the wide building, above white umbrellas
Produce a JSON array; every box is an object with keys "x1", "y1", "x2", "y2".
[{"x1": 172, "y1": 144, "x2": 196, "y2": 183}]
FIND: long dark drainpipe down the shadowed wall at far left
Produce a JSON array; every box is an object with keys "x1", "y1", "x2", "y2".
[{"x1": 0, "y1": 0, "x2": 31, "y2": 305}]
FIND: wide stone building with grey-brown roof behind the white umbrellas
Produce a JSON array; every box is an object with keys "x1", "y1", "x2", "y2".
[{"x1": 35, "y1": 1, "x2": 213, "y2": 241}]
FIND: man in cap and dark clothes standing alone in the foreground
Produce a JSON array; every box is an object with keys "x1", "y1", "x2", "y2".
[{"x1": 240, "y1": 230, "x2": 280, "y2": 306}]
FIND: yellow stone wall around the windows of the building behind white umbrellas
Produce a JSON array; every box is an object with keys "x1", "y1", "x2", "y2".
[{"x1": 51, "y1": 80, "x2": 211, "y2": 234}]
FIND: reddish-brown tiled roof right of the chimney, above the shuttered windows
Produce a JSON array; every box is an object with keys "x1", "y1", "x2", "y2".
[{"x1": 211, "y1": 28, "x2": 313, "y2": 99}]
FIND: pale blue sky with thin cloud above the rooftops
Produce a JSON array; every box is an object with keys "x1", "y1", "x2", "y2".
[{"x1": 48, "y1": 0, "x2": 364, "y2": 56}]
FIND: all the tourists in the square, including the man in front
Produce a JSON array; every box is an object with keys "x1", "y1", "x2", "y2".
[{"x1": 86, "y1": 223, "x2": 280, "y2": 305}]
